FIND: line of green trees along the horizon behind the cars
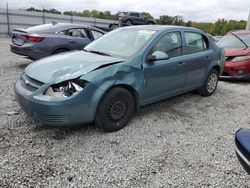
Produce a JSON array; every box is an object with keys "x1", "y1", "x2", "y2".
[{"x1": 26, "y1": 7, "x2": 247, "y2": 36}]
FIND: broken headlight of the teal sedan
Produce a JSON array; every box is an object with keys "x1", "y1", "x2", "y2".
[{"x1": 44, "y1": 79, "x2": 87, "y2": 98}]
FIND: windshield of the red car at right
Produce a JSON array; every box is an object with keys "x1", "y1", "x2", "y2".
[{"x1": 217, "y1": 35, "x2": 250, "y2": 47}]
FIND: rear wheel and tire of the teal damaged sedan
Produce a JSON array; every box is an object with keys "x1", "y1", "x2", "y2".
[{"x1": 198, "y1": 69, "x2": 219, "y2": 97}]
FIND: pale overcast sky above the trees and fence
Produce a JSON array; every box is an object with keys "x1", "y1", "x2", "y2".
[{"x1": 0, "y1": 0, "x2": 250, "y2": 22}]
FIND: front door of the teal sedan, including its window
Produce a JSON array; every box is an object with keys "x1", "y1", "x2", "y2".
[{"x1": 141, "y1": 31, "x2": 186, "y2": 104}]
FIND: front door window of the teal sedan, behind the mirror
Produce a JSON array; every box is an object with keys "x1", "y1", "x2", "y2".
[{"x1": 150, "y1": 32, "x2": 182, "y2": 58}]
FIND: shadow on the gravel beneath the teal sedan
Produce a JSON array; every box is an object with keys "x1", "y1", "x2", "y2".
[{"x1": 26, "y1": 92, "x2": 197, "y2": 140}]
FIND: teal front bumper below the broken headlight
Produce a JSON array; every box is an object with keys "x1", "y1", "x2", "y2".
[{"x1": 15, "y1": 79, "x2": 103, "y2": 126}]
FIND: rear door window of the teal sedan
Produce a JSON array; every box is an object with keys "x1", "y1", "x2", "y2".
[{"x1": 184, "y1": 32, "x2": 208, "y2": 54}]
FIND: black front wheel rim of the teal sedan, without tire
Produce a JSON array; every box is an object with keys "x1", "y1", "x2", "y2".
[{"x1": 108, "y1": 99, "x2": 126, "y2": 121}]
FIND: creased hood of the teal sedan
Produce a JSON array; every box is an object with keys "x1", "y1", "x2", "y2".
[{"x1": 25, "y1": 51, "x2": 124, "y2": 84}]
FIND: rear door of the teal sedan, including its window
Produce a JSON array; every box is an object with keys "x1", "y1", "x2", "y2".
[{"x1": 183, "y1": 31, "x2": 213, "y2": 90}]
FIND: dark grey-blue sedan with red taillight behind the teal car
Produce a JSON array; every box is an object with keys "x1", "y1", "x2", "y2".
[{"x1": 10, "y1": 23, "x2": 105, "y2": 60}]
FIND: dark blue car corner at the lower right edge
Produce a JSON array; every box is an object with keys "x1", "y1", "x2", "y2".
[{"x1": 235, "y1": 129, "x2": 250, "y2": 175}]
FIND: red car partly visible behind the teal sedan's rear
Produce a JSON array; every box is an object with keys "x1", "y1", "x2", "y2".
[{"x1": 217, "y1": 30, "x2": 250, "y2": 80}]
